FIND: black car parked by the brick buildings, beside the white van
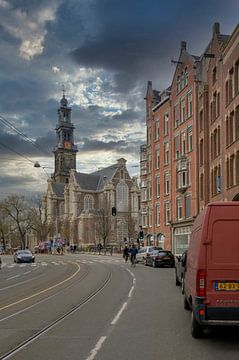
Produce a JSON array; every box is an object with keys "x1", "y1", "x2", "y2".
[{"x1": 145, "y1": 250, "x2": 175, "y2": 267}]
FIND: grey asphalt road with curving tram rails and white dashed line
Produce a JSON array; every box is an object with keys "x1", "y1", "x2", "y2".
[{"x1": 0, "y1": 254, "x2": 239, "y2": 360}]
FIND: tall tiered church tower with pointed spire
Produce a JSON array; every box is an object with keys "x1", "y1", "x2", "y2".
[{"x1": 53, "y1": 89, "x2": 78, "y2": 183}]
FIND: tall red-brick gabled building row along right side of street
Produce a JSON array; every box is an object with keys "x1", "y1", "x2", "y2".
[{"x1": 141, "y1": 23, "x2": 239, "y2": 254}]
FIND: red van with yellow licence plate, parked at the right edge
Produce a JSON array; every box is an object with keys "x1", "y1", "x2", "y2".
[{"x1": 184, "y1": 201, "x2": 239, "y2": 338}]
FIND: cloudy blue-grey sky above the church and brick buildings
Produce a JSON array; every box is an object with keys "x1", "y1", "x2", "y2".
[{"x1": 0, "y1": 0, "x2": 239, "y2": 198}]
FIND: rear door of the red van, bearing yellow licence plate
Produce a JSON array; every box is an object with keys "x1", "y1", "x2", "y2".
[{"x1": 204, "y1": 205, "x2": 239, "y2": 307}]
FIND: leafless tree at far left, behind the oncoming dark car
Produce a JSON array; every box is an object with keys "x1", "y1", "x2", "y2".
[{"x1": 0, "y1": 195, "x2": 32, "y2": 249}]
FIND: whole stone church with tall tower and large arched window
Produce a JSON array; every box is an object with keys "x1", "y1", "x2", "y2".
[{"x1": 44, "y1": 93, "x2": 140, "y2": 248}]
